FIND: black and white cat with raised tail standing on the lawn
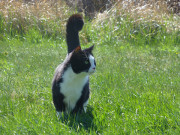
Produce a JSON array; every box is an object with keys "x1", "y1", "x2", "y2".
[{"x1": 52, "y1": 14, "x2": 96, "y2": 114}]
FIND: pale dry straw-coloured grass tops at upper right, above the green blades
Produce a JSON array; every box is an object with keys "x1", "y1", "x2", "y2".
[{"x1": 96, "y1": 0, "x2": 180, "y2": 31}]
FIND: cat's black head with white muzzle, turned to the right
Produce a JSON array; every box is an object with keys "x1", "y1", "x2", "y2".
[{"x1": 70, "y1": 45, "x2": 96, "y2": 74}]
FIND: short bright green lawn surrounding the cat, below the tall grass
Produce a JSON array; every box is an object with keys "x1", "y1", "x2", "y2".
[{"x1": 0, "y1": 33, "x2": 180, "y2": 134}]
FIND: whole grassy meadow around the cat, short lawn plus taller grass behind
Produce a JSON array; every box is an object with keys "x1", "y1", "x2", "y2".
[{"x1": 0, "y1": 1, "x2": 180, "y2": 135}]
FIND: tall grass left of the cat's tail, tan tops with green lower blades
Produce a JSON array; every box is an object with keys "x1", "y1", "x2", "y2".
[{"x1": 0, "y1": 0, "x2": 72, "y2": 35}]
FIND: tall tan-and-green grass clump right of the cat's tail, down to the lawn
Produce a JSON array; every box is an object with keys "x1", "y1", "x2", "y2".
[{"x1": 91, "y1": 0, "x2": 180, "y2": 45}]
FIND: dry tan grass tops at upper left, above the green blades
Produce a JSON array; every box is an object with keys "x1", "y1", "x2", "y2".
[{"x1": 0, "y1": 0, "x2": 68, "y2": 20}]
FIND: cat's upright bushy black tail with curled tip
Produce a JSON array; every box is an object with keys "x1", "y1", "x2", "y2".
[{"x1": 66, "y1": 14, "x2": 84, "y2": 53}]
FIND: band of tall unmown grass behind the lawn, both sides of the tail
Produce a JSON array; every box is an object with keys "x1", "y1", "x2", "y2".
[{"x1": 0, "y1": 0, "x2": 180, "y2": 45}]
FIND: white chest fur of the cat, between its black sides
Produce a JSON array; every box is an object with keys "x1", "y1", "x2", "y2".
[{"x1": 60, "y1": 67, "x2": 89, "y2": 111}]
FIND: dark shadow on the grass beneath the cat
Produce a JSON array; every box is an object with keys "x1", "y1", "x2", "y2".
[{"x1": 60, "y1": 106, "x2": 97, "y2": 132}]
